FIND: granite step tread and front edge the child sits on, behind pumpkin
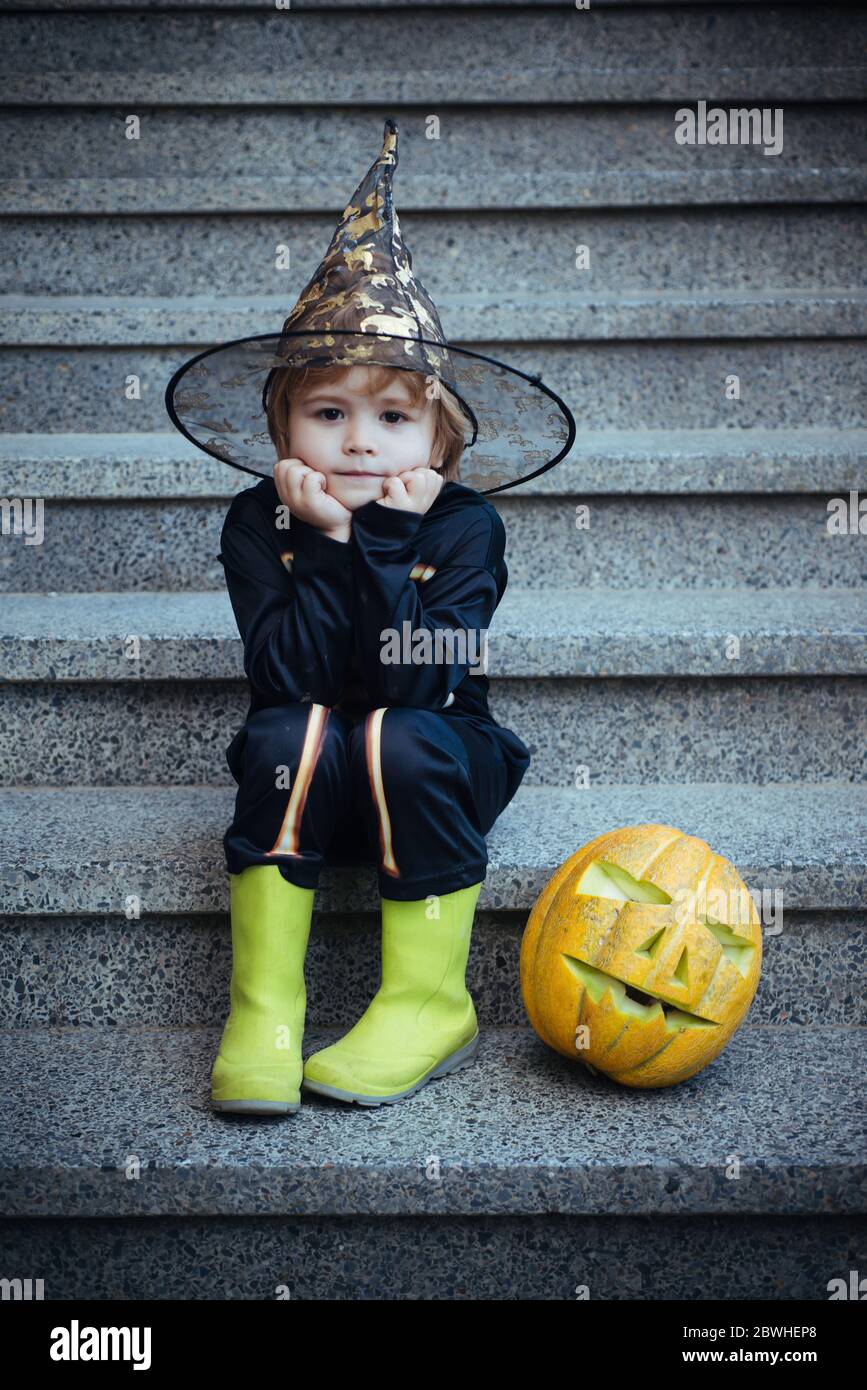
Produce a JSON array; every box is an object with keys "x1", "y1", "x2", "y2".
[{"x1": 0, "y1": 783, "x2": 867, "y2": 916}]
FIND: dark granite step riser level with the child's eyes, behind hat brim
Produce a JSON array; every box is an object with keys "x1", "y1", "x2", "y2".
[{"x1": 0, "y1": 339, "x2": 867, "y2": 430}]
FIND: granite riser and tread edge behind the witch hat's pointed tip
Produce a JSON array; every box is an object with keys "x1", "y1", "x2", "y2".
[{"x1": 6, "y1": 104, "x2": 867, "y2": 215}]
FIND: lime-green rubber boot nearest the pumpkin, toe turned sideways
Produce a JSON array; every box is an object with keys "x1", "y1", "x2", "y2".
[{"x1": 302, "y1": 883, "x2": 482, "y2": 1105}]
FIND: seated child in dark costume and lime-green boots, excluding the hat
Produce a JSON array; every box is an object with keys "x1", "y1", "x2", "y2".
[{"x1": 213, "y1": 353, "x2": 529, "y2": 1109}]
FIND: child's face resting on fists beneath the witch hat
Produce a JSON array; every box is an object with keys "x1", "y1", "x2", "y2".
[{"x1": 289, "y1": 367, "x2": 439, "y2": 512}]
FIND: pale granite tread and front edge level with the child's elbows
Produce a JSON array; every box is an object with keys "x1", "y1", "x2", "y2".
[{"x1": 0, "y1": 587, "x2": 867, "y2": 681}]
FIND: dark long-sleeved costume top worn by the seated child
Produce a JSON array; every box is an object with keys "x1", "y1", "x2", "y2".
[{"x1": 220, "y1": 467, "x2": 527, "y2": 795}]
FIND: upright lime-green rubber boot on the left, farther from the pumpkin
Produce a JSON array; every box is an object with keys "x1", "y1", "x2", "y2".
[{"x1": 211, "y1": 865, "x2": 315, "y2": 1115}]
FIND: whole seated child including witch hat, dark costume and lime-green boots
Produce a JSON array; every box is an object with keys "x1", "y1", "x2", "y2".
[{"x1": 167, "y1": 121, "x2": 574, "y2": 1113}]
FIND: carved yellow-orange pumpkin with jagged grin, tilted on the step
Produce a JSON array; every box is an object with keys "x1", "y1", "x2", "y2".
[{"x1": 521, "y1": 826, "x2": 761, "y2": 1087}]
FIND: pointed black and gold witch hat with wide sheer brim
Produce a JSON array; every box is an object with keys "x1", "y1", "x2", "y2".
[{"x1": 165, "y1": 117, "x2": 575, "y2": 492}]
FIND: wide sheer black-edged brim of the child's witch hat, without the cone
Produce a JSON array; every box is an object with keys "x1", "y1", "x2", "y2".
[{"x1": 165, "y1": 329, "x2": 575, "y2": 493}]
